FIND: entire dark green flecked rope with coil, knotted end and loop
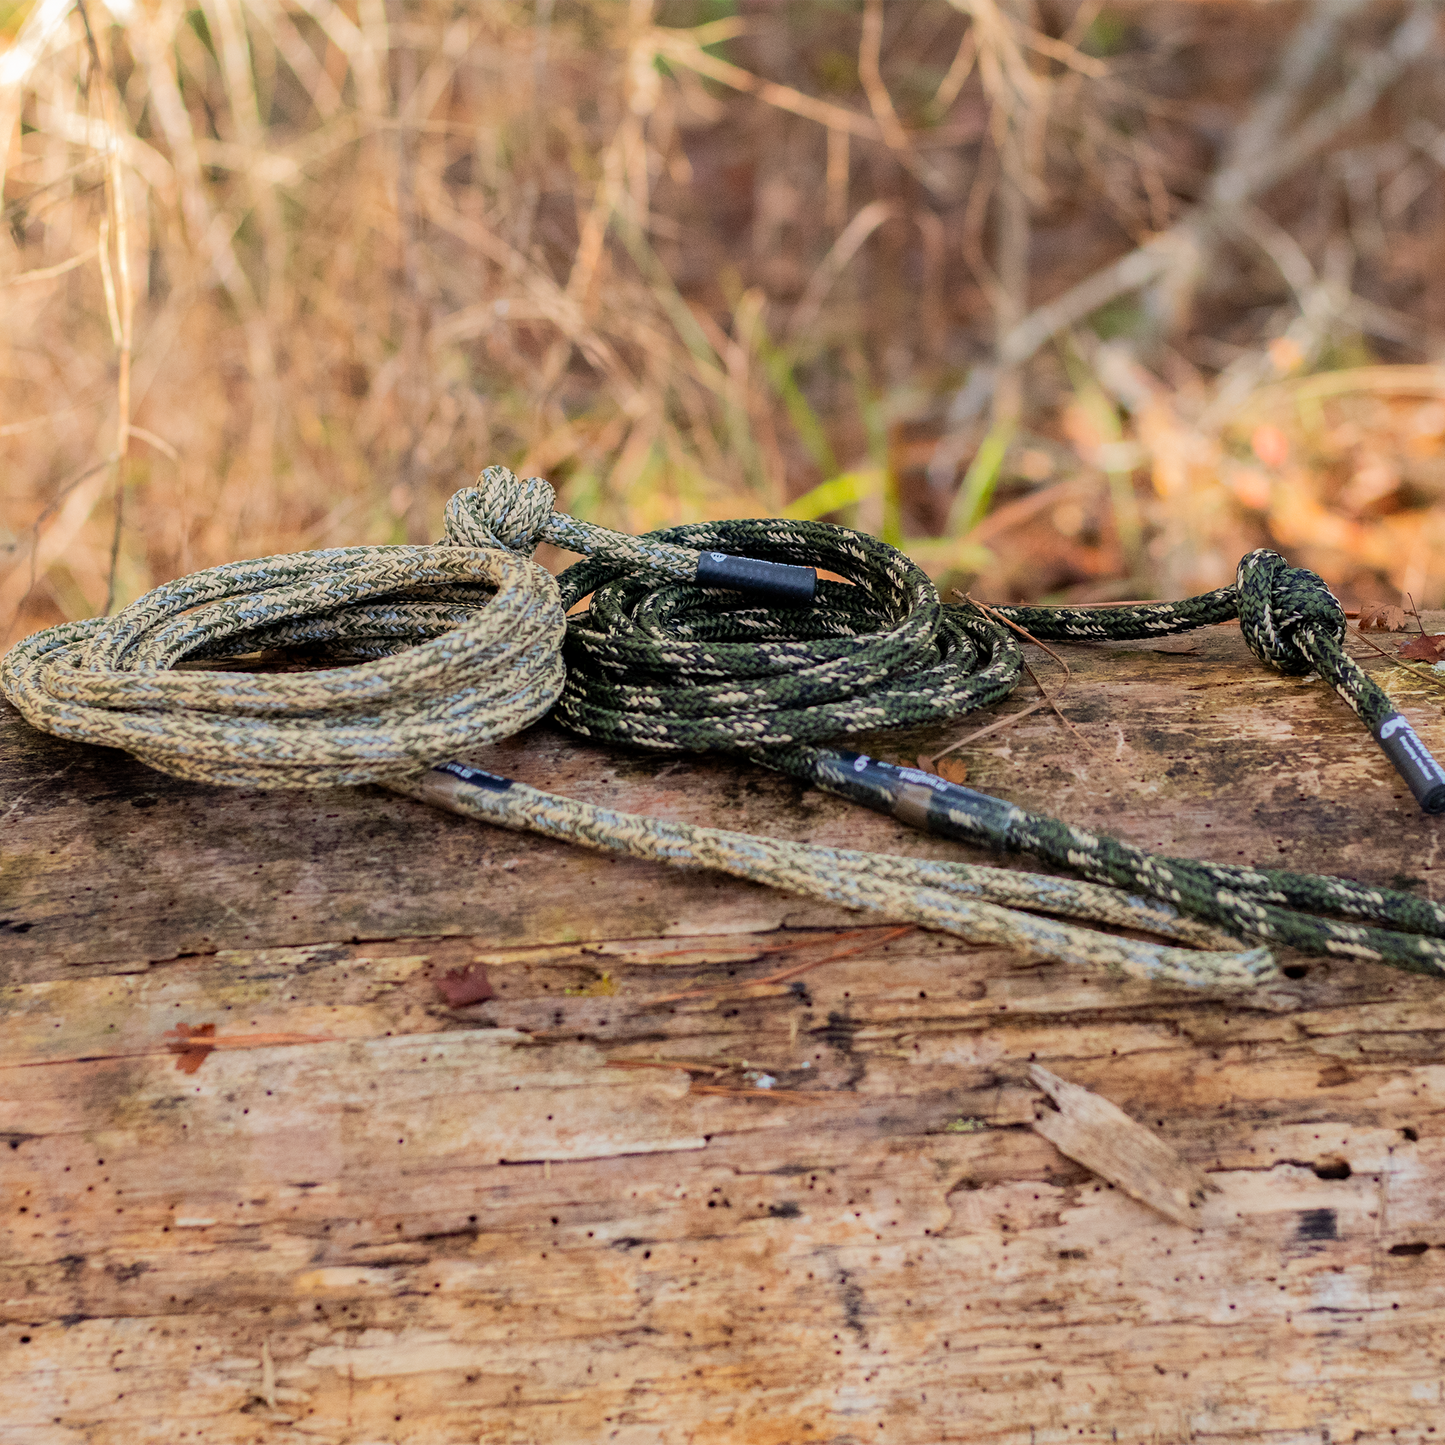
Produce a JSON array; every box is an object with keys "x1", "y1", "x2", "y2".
[{"x1": 483, "y1": 468, "x2": 1445, "y2": 977}]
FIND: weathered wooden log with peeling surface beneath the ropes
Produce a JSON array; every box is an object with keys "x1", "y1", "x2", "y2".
[{"x1": 0, "y1": 617, "x2": 1445, "y2": 1445}]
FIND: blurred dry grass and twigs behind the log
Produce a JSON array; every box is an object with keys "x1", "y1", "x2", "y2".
[{"x1": 0, "y1": 0, "x2": 1445, "y2": 637}]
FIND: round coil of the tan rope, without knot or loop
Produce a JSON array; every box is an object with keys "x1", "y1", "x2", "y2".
[{"x1": 0, "y1": 517, "x2": 566, "y2": 788}]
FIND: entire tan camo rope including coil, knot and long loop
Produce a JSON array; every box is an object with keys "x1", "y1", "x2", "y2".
[{"x1": 0, "y1": 468, "x2": 1274, "y2": 987}]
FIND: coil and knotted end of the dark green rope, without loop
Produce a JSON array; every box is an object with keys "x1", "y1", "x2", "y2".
[{"x1": 556, "y1": 520, "x2": 1394, "y2": 760}]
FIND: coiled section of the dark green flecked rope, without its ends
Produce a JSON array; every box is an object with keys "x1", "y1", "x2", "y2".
[{"x1": 556, "y1": 522, "x2": 1023, "y2": 759}]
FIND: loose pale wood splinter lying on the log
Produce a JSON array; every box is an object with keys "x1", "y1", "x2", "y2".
[{"x1": 1029, "y1": 1064, "x2": 1218, "y2": 1230}]
